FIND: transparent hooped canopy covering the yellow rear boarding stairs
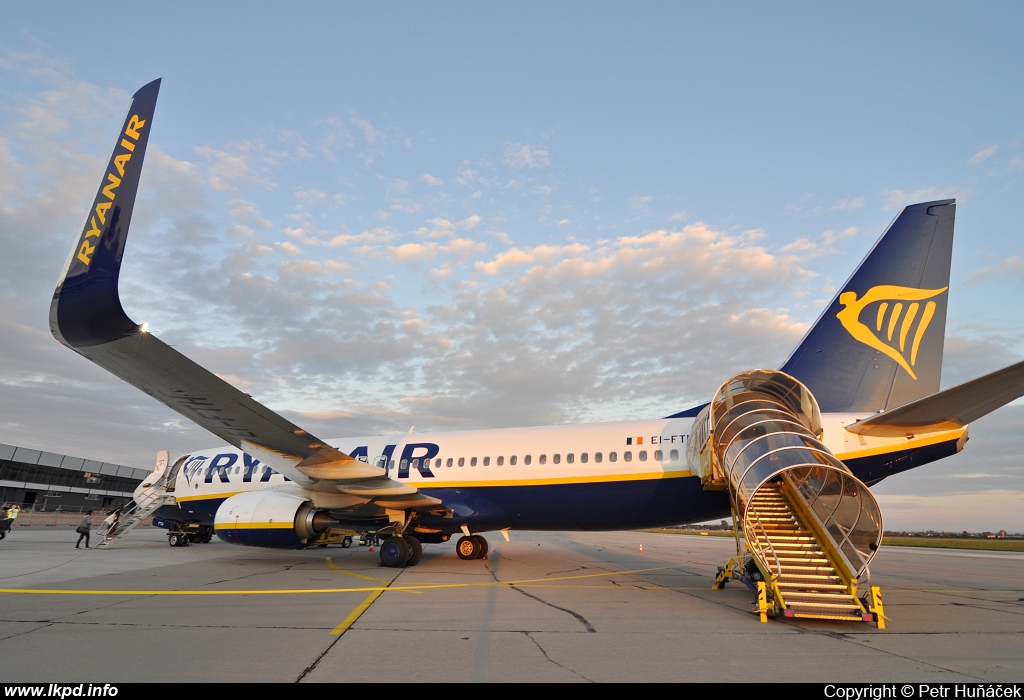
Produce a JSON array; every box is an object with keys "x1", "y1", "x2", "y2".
[{"x1": 688, "y1": 369, "x2": 883, "y2": 582}]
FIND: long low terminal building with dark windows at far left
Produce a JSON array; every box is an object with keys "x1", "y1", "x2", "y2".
[{"x1": 0, "y1": 443, "x2": 152, "y2": 513}]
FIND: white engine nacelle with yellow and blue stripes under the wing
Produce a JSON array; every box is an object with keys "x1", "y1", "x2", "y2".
[{"x1": 214, "y1": 491, "x2": 333, "y2": 549}]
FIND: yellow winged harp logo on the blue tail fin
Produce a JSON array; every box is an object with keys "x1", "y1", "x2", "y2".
[{"x1": 836, "y1": 285, "x2": 949, "y2": 380}]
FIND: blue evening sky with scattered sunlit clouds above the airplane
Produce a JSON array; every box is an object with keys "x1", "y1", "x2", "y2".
[{"x1": 0, "y1": 0, "x2": 1024, "y2": 532}]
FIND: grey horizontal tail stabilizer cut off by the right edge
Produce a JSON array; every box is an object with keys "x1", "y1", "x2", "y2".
[{"x1": 846, "y1": 361, "x2": 1024, "y2": 437}]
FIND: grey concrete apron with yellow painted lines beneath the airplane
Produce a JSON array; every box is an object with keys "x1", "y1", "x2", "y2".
[{"x1": 0, "y1": 525, "x2": 1024, "y2": 684}]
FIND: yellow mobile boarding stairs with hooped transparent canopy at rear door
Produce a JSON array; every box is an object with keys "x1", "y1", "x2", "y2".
[{"x1": 688, "y1": 369, "x2": 885, "y2": 628}]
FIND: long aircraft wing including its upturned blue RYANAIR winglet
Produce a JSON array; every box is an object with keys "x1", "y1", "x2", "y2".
[{"x1": 50, "y1": 80, "x2": 440, "y2": 506}]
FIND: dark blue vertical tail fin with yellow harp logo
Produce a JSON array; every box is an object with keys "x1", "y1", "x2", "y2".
[{"x1": 781, "y1": 200, "x2": 956, "y2": 412}]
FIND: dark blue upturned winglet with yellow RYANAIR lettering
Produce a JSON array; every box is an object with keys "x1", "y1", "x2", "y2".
[{"x1": 50, "y1": 78, "x2": 160, "y2": 348}]
